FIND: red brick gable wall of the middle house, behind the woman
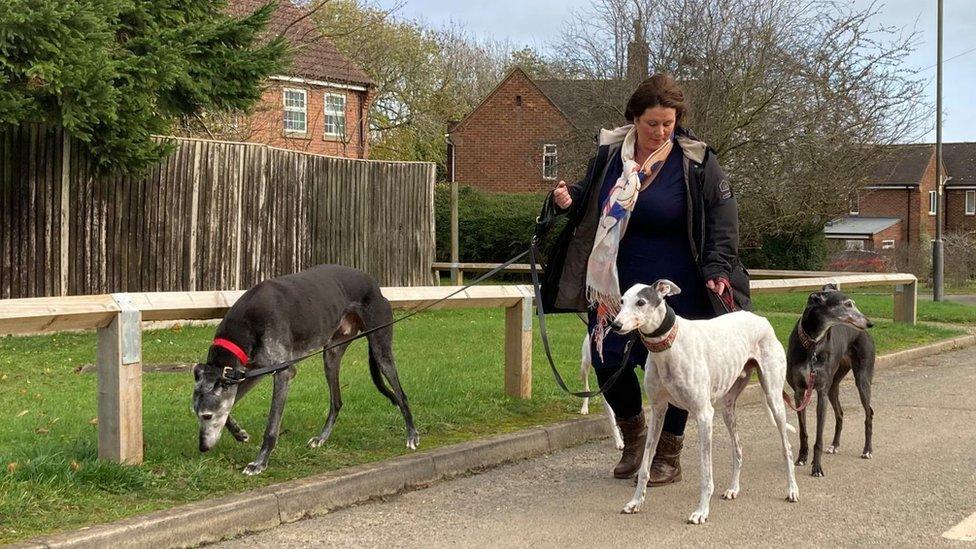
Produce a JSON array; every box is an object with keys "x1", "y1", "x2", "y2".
[{"x1": 448, "y1": 70, "x2": 570, "y2": 192}]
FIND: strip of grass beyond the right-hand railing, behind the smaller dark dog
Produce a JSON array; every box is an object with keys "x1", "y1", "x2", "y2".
[{"x1": 752, "y1": 288, "x2": 976, "y2": 324}]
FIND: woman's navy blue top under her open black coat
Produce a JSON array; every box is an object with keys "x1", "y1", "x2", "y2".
[{"x1": 589, "y1": 139, "x2": 715, "y2": 368}]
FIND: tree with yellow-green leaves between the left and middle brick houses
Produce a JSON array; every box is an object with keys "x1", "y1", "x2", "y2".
[{"x1": 316, "y1": 0, "x2": 510, "y2": 173}]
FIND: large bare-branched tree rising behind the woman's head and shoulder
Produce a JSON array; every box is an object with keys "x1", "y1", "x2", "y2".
[{"x1": 553, "y1": 0, "x2": 927, "y2": 255}]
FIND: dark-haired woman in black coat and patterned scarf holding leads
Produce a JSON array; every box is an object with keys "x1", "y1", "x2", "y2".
[{"x1": 542, "y1": 74, "x2": 750, "y2": 486}]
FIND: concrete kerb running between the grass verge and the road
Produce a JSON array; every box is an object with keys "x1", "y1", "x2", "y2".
[{"x1": 21, "y1": 334, "x2": 976, "y2": 549}]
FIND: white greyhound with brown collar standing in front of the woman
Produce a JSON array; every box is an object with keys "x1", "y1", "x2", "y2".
[{"x1": 611, "y1": 280, "x2": 800, "y2": 524}]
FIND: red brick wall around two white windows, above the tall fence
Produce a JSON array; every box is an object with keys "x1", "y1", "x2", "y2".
[{"x1": 245, "y1": 82, "x2": 371, "y2": 158}]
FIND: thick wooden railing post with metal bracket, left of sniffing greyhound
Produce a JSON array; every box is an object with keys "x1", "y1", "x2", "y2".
[{"x1": 97, "y1": 294, "x2": 142, "y2": 465}]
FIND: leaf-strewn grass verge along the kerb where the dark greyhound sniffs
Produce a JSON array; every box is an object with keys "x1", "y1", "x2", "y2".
[{"x1": 0, "y1": 305, "x2": 958, "y2": 543}]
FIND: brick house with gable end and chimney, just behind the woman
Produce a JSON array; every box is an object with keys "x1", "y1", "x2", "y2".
[{"x1": 447, "y1": 23, "x2": 649, "y2": 192}]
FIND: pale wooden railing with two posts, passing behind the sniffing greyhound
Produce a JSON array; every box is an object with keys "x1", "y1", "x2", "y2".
[{"x1": 0, "y1": 286, "x2": 532, "y2": 464}]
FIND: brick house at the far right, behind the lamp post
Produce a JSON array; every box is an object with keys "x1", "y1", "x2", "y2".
[{"x1": 824, "y1": 143, "x2": 976, "y2": 250}]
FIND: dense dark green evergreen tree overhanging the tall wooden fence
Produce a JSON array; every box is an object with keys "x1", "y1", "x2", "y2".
[{"x1": 0, "y1": 0, "x2": 288, "y2": 171}]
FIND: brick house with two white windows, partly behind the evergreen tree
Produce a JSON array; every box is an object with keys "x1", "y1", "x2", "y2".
[{"x1": 200, "y1": 0, "x2": 376, "y2": 158}]
